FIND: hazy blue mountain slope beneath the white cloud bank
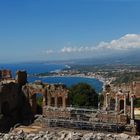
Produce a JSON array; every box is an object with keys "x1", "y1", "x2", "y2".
[{"x1": 46, "y1": 51, "x2": 140, "y2": 65}]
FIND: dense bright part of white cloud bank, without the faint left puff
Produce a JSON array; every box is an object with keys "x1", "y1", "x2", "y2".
[{"x1": 60, "y1": 34, "x2": 140, "y2": 53}]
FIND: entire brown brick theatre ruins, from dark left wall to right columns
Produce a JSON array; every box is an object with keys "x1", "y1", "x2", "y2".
[{"x1": 0, "y1": 70, "x2": 140, "y2": 132}]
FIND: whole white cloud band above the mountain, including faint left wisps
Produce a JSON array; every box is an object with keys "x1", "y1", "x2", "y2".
[{"x1": 45, "y1": 34, "x2": 140, "y2": 57}]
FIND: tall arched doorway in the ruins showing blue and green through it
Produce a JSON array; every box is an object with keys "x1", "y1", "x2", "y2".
[{"x1": 30, "y1": 93, "x2": 43, "y2": 114}]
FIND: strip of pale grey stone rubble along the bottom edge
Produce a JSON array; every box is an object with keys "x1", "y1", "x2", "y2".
[{"x1": 0, "y1": 130, "x2": 140, "y2": 140}]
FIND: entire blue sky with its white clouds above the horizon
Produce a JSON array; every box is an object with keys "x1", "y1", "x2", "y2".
[{"x1": 0, "y1": 0, "x2": 140, "y2": 63}]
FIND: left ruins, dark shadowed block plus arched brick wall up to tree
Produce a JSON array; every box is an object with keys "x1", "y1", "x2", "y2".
[{"x1": 0, "y1": 70, "x2": 68, "y2": 132}]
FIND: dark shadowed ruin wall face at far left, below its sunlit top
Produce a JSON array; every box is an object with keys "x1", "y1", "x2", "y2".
[{"x1": 0, "y1": 82, "x2": 33, "y2": 131}]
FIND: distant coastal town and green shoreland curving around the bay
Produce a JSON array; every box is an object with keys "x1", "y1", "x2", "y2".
[{"x1": 29, "y1": 65, "x2": 140, "y2": 88}]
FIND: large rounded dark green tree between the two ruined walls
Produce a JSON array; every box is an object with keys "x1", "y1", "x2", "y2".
[{"x1": 69, "y1": 83, "x2": 98, "y2": 107}]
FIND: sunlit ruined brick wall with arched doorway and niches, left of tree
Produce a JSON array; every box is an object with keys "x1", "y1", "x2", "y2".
[{"x1": 22, "y1": 81, "x2": 68, "y2": 115}]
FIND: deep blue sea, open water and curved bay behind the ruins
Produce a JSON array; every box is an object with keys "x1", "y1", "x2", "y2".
[{"x1": 0, "y1": 63, "x2": 103, "y2": 93}]
